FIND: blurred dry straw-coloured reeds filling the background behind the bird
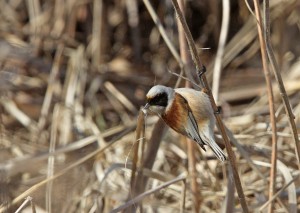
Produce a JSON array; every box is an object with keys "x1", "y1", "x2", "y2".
[{"x1": 0, "y1": 0, "x2": 300, "y2": 212}]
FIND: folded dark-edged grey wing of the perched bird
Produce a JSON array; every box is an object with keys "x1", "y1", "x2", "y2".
[{"x1": 182, "y1": 97, "x2": 206, "y2": 151}]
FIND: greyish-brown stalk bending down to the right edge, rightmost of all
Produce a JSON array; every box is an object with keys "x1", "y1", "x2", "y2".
[{"x1": 264, "y1": 0, "x2": 300, "y2": 166}]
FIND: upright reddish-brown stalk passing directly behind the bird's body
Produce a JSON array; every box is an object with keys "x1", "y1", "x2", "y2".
[{"x1": 177, "y1": 0, "x2": 201, "y2": 212}]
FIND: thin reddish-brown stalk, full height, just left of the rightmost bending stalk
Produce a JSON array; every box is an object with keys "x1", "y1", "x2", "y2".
[{"x1": 254, "y1": 0, "x2": 277, "y2": 213}]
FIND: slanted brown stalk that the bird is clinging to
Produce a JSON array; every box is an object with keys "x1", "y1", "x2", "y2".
[{"x1": 172, "y1": 0, "x2": 248, "y2": 212}]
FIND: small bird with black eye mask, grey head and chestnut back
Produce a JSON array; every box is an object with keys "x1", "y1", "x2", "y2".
[{"x1": 143, "y1": 85, "x2": 226, "y2": 161}]
